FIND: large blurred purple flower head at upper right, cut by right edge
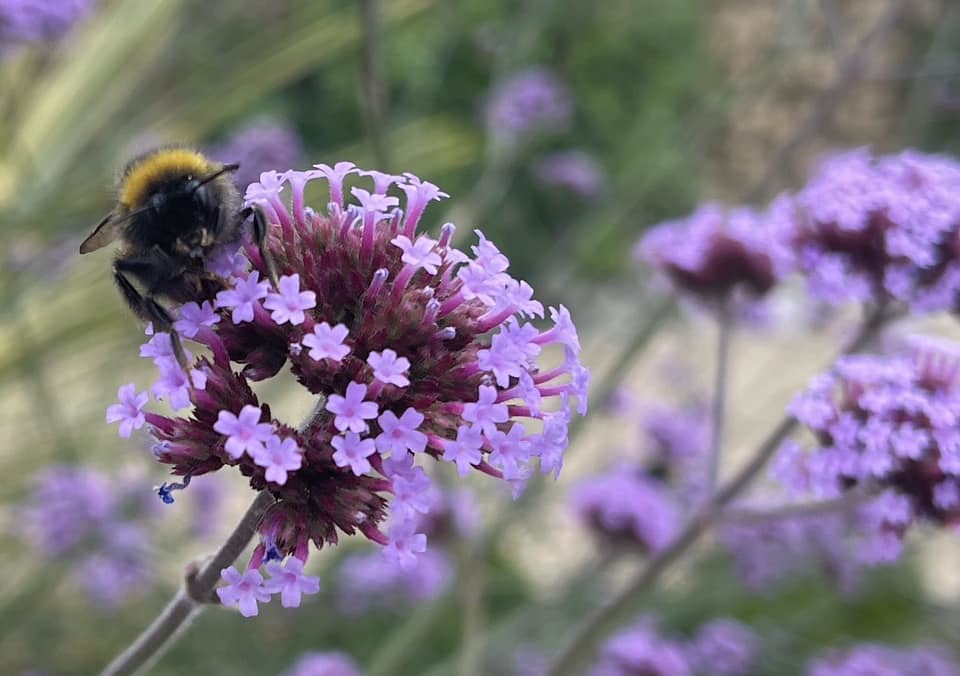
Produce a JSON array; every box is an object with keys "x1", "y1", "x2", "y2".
[{"x1": 771, "y1": 148, "x2": 960, "y2": 312}]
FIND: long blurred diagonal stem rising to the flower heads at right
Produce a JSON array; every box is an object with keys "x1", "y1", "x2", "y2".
[{"x1": 546, "y1": 308, "x2": 893, "y2": 676}]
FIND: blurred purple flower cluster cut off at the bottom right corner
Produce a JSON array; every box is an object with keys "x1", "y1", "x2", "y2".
[{"x1": 806, "y1": 643, "x2": 960, "y2": 676}]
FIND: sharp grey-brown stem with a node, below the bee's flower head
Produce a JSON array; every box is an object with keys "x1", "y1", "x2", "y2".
[{"x1": 101, "y1": 491, "x2": 274, "y2": 676}]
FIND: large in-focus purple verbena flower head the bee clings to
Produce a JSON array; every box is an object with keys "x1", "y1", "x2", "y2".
[{"x1": 103, "y1": 162, "x2": 589, "y2": 613}]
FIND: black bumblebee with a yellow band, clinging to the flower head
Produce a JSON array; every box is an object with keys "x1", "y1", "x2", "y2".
[{"x1": 80, "y1": 147, "x2": 277, "y2": 367}]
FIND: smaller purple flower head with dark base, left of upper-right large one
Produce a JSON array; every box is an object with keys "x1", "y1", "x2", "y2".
[{"x1": 635, "y1": 203, "x2": 790, "y2": 303}]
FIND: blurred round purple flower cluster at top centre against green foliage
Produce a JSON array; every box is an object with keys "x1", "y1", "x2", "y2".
[{"x1": 486, "y1": 68, "x2": 573, "y2": 141}]
